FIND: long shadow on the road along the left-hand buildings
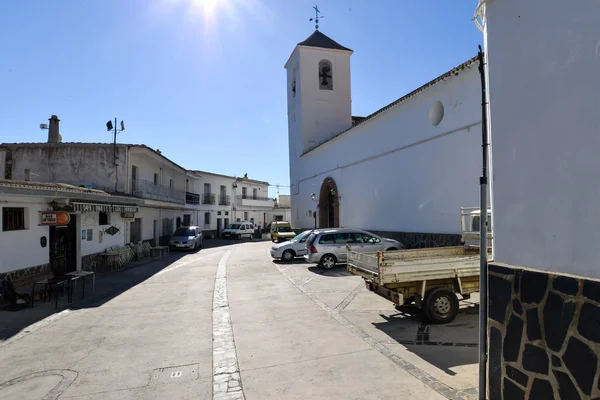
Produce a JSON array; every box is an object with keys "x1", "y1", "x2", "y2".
[{"x1": 0, "y1": 239, "x2": 240, "y2": 345}]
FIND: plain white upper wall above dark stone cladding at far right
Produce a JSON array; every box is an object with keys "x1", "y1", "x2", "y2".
[{"x1": 486, "y1": 0, "x2": 600, "y2": 278}]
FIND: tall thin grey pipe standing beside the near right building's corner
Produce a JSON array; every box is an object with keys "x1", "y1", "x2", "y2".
[{"x1": 478, "y1": 46, "x2": 489, "y2": 400}]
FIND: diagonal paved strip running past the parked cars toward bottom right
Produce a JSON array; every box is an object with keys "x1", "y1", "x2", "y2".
[{"x1": 273, "y1": 253, "x2": 478, "y2": 400}]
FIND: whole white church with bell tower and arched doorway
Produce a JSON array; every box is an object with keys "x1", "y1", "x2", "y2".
[{"x1": 285, "y1": 29, "x2": 482, "y2": 248}]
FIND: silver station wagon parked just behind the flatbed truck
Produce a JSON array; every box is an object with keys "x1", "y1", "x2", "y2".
[{"x1": 304, "y1": 228, "x2": 403, "y2": 269}]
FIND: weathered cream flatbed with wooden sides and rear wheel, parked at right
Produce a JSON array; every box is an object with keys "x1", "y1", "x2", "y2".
[{"x1": 347, "y1": 246, "x2": 479, "y2": 324}]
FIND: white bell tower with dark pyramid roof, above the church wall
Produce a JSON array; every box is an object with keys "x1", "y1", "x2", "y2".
[{"x1": 285, "y1": 30, "x2": 353, "y2": 158}]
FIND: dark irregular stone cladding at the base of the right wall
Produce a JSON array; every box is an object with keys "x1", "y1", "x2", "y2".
[{"x1": 489, "y1": 264, "x2": 600, "y2": 400}]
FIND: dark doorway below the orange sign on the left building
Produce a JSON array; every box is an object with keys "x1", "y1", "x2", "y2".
[{"x1": 49, "y1": 214, "x2": 79, "y2": 276}]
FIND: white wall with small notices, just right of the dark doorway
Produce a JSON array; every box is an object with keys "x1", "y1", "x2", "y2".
[{"x1": 77, "y1": 212, "x2": 126, "y2": 256}]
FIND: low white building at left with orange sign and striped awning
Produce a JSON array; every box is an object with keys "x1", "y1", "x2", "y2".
[{"x1": 0, "y1": 179, "x2": 141, "y2": 279}]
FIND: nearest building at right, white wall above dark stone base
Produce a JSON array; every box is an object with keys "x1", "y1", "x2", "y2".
[{"x1": 478, "y1": 0, "x2": 600, "y2": 400}]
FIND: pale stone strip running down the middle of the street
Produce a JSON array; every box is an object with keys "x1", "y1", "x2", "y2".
[{"x1": 212, "y1": 250, "x2": 244, "y2": 400}]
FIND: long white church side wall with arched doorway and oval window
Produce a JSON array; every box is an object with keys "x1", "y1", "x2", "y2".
[{"x1": 290, "y1": 63, "x2": 481, "y2": 233}]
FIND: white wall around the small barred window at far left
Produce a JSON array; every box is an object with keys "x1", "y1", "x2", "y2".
[{"x1": 0, "y1": 195, "x2": 51, "y2": 272}]
